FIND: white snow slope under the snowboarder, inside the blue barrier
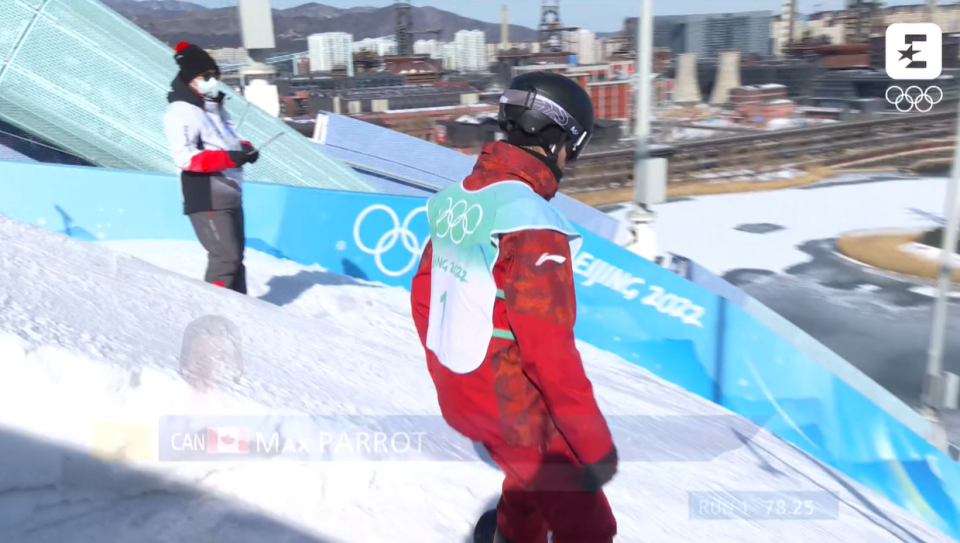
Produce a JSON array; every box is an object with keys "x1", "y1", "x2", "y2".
[{"x1": 0, "y1": 216, "x2": 950, "y2": 543}]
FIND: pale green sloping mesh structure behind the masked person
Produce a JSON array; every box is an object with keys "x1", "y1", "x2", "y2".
[{"x1": 0, "y1": 0, "x2": 375, "y2": 192}]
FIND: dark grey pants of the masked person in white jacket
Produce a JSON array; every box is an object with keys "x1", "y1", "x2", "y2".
[{"x1": 189, "y1": 208, "x2": 247, "y2": 294}]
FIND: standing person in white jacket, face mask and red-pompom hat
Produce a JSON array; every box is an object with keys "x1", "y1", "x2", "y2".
[{"x1": 164, "y1": 42, "x2": 259, "y2": 294}]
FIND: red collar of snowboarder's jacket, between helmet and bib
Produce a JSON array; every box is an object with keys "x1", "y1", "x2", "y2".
[{"x1": 463, "y1": 141, "x2": 558, "y2": 200}]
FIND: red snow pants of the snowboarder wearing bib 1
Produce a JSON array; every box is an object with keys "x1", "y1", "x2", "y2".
[{"x1": 486, "y1": 436, "x2": 617, "y2": 543}]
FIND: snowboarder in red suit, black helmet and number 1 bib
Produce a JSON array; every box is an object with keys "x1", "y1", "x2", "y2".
[{"x1": 411, "y1": 72, "x2": 617, "y2": 543}]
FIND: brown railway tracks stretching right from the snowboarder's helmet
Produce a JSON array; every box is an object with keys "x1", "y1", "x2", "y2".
[{"x1": 564, "y1": 111, "x2": 957, "y2": 193}]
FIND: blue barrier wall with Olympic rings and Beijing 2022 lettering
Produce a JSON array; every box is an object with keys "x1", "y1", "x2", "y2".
[{"x1": 0, "y1": 162, "x2": 960, "y2": 539}]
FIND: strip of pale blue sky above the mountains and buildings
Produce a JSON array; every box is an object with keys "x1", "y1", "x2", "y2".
[{"x1": 191, "y1": 0, "x2": 936, "y2": 32}]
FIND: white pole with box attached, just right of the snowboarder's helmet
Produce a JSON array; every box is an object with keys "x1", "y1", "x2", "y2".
[{"x1": 626, "y1": 0, "x2": 666, "y2": 261}]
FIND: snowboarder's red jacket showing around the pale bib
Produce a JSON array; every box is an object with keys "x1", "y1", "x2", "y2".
[{"x1": 410, "y1": 142, "x2": 614, "y2": 470}]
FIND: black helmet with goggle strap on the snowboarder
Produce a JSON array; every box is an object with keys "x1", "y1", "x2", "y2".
[{"x1": 499, "y1": 72, "x2": 593, "y2": 162}]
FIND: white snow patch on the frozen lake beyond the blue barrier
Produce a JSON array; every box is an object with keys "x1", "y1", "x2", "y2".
[{"x1": 655, "y1": 176, "x2": 946, "y2": 275}]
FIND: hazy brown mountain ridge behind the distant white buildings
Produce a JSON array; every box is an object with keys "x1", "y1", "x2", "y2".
[{"x1": 101, "y1": 0, "x2": 538, "y2": 53}]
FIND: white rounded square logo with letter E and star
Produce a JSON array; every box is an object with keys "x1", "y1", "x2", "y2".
[{"x1": 885, "y1": 23, "x2": 943, "y2": 80}]
